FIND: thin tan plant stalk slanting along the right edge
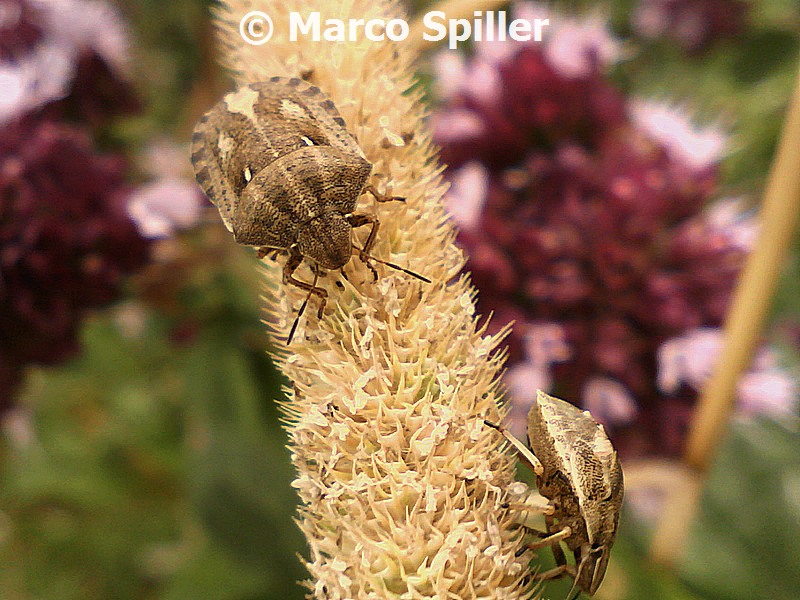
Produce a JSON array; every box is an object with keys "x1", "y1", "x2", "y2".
[{"x1": 651, "y1": 61, "x2": 800, "y2": 564}]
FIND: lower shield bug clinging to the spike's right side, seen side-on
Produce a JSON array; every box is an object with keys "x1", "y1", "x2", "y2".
[{"x1": 486, "y1": 391, "x2": 623, "y2": 600}]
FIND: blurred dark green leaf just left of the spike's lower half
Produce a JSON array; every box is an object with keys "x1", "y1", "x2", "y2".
[{"x1": 184, "y1": 335, "x2": 307, "y2": 598}]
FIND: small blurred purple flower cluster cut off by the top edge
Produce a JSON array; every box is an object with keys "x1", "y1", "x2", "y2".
[{"x1": 632, "y1": 0, "x2": 748, "y2": 54}]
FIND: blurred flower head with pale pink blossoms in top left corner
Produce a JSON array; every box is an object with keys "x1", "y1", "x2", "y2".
[{"x1": 0, "y1": 0, "x2": 139, "y2": 126}]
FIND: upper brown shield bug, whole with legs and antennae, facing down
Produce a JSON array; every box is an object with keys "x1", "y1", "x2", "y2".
[{"x1": 192, "y1": 77, "x2": 429, "y2": 343}]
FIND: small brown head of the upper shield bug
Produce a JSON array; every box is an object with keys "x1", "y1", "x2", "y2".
[{"x1": 297, "y1": 212, "x2": 353, "y2": 270}]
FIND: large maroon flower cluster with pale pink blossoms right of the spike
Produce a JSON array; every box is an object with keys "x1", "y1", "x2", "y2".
[{"x1": 433, "y1": 7, "x2": 788, "y2": 454}]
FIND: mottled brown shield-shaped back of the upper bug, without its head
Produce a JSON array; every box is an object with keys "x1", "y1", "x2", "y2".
[{"x1": 192, "y1": 77, "x2": 372, "y2": 248}]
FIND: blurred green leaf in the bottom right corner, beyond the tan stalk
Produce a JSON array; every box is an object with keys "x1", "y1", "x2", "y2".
[{"x1": 681, "y1": 418, "x2": 800, "y2": 600}]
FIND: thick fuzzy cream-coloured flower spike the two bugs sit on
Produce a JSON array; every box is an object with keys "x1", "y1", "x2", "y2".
[{"x1": 209, "y1": 0, "x2": 533, "y2": 599}]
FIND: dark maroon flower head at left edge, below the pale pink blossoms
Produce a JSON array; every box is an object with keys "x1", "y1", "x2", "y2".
[{"x1": 0, "y1": 119, "x2": 147, "y2": 406}]
